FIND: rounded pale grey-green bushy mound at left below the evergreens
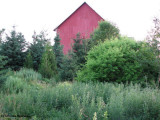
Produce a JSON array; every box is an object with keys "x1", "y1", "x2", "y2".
[{"x1": 2, "y1": 68, "x2": 46, "y2": 94}]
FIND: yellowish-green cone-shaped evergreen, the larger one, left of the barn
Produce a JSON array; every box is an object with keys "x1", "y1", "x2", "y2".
[{"x1": 39, "y1": 43, "x2": 57, "y2": 78}]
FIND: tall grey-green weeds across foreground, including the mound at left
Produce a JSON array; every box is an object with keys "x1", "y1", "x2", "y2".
[{"x1": 0, "y1": 69, "x2": 160, "y2": 120}]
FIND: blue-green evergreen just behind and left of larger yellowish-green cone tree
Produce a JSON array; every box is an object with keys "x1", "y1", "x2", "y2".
[{"x1": 28, "y1": 31, "x2": 49, "y2": 70}]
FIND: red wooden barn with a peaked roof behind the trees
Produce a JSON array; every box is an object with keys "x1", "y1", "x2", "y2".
[{"x1": 54, "y1": 2, "x2": 103, "y2": 54}]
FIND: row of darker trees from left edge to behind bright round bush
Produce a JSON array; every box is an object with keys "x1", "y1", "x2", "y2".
[{"x1": 0, "y1": 22, "x2": 119, "y2": 81}]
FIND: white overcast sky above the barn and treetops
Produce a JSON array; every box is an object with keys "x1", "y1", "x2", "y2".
[{"x1": 0, "y1": 0, "x2": 160, "y2": 41}]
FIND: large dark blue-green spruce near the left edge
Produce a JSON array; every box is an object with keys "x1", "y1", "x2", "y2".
[{"x1": 0, "y1": 29, "x2": 27, "y2": 70}]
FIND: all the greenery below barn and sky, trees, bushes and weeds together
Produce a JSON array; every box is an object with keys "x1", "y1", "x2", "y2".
[{"x1": 0, "y1": 20, "x2": 160, "y2": 120}]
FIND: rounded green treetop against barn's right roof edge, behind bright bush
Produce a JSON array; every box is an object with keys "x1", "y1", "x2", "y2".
[{"x1": 90, "y1": 21, "x2": 119, "y2": 47}]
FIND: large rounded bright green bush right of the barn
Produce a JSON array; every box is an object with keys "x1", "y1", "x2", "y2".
[{"x1": 77, "y1": 37, "x2": 159, "y2": 83}]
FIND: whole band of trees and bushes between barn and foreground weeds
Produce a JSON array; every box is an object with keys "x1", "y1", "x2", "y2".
[{"x1": 0, "y1": 19, "x2": 160, "y2": 82}]
